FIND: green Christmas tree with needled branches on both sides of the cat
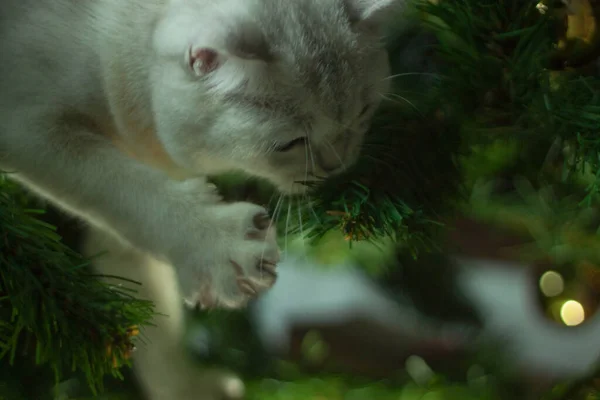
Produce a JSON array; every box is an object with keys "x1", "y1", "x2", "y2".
[{"x1": 0, "y1": 0, "x2": 600, "y2": 400}]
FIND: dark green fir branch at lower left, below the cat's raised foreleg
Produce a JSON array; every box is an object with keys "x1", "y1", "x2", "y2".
[{"x1": 0, "y1": 177, "x2": 153, "y2": 391}]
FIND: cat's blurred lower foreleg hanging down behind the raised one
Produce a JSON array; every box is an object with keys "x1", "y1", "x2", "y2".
[{"x1": 84, "y1": 230, "x2": 244, "y2": 400}]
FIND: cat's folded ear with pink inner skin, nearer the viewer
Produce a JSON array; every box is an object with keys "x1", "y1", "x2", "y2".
[{"x1": 187, "y1": 23, "x2": 273, "y2": 76}]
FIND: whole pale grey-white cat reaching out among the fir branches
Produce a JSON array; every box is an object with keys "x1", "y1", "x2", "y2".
[{"x1": 0, "y1": 0, "x2": 401, "y2": 400}]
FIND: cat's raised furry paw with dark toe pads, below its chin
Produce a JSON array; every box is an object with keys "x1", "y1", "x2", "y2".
[{"x1": 182, "y1": 202, "x2": 280, "y2": 308}]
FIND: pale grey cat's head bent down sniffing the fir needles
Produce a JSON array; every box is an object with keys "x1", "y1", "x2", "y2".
[{"x1": 150, "y1": 0, "x2": 404, "y2": 192}]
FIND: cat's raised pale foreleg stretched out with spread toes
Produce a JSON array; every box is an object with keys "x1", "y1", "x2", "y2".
[{"x1": 0, "y1": 117, "x2": 279, "y2": 307}]
